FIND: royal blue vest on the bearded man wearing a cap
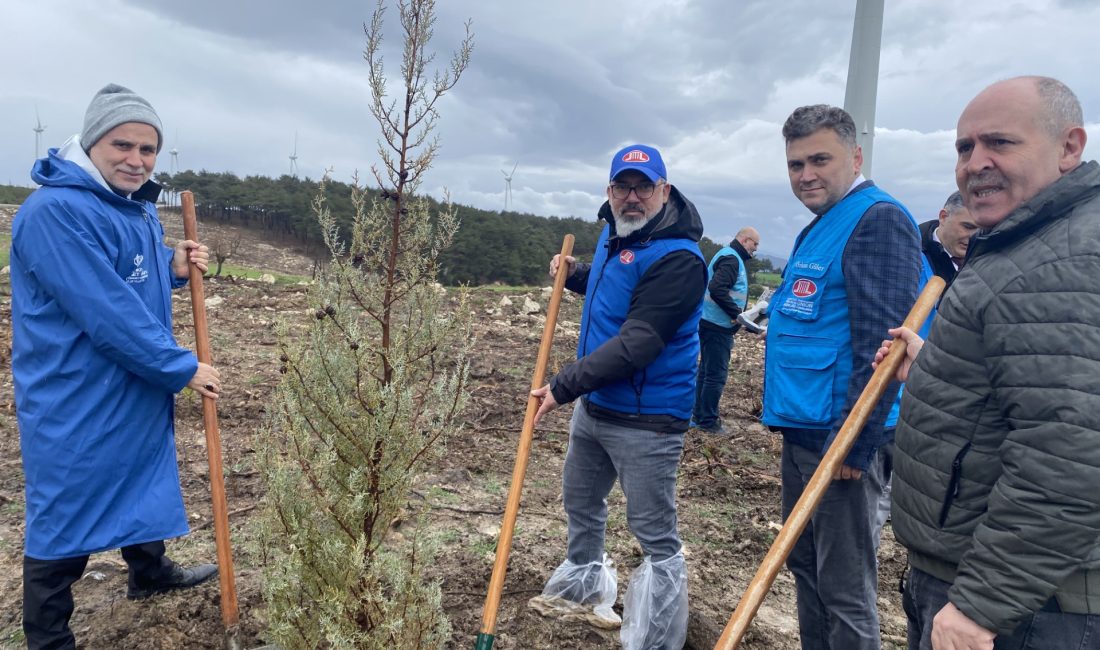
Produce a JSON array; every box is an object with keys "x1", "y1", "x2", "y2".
[{"x1": 576, "y1": 228, "x2": 703, "y2": 420}]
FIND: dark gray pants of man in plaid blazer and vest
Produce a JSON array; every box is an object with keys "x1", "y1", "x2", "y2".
[{"x1": 782, "y1": 441, "x2": 893, "y2": 650}]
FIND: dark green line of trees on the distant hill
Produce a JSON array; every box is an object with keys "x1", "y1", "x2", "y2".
[{"x1": 0, "y1": 175, "x2": 777, "y2": 295}]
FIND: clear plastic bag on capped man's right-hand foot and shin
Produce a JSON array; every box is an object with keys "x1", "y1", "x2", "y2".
[{"x1": 619, "y1": 552, "x2": 688, "y2": 650}]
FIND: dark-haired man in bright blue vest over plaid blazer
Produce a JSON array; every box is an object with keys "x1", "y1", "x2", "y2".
[{"x1": 762, "y1": 104, "x2": 922, "y2": 650}]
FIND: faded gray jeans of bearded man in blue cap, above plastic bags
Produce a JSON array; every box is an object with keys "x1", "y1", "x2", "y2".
[{"x1": 562, "y1": 400, "x2": 684, "y2": 564}]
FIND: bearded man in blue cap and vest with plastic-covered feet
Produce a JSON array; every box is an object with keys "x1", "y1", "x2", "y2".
[{"x1": 531, "y1": 144, "x2": 706, "y2": 649}]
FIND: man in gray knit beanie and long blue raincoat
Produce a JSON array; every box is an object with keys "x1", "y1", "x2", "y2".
[{"x1": 11, "y1": 84, "x2": 221, "y2": 650}]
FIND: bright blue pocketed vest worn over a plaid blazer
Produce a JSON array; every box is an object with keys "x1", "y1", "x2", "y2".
[{"x1": 761, "y1": 186, "x2": 931, "y2": 429}]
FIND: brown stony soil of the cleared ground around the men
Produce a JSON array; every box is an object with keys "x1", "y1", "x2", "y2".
[{"x1": 0, "y1": 207, "x2": 905, "y2": 650}]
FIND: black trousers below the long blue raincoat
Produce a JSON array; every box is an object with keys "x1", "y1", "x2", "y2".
[{"x1": 23, "y1": 541, "x2": 172, "y2": 650}]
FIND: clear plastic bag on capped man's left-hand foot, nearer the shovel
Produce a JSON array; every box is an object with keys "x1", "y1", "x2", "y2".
[{"x1": 530, "y1": 553, "x2": 623, "y2": 629}]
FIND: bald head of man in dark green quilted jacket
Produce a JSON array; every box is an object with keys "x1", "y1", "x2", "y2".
[{"x1": 955, "y1": 77, "x2": 1086, "y2": 228}]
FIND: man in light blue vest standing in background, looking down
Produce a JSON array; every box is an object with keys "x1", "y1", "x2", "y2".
[{"x1": 692, "y1": 227, "x2": 763, "y2": 436}]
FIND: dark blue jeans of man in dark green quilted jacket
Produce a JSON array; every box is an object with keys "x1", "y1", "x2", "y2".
[{"x1": 902, "y1": 569, "x2": 1100, "y2": 650}]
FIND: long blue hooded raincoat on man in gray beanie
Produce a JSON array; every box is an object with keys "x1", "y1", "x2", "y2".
[{"x1": 11, "y1": 150, "x2": 198, "y2": 560}]
